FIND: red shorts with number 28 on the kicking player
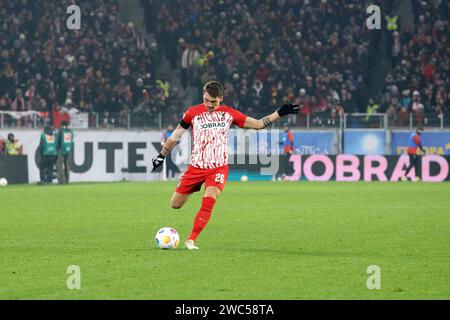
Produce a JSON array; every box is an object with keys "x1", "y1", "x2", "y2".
[{"x1": 175, "y1": 165, "x2": 228, "y2": 194}]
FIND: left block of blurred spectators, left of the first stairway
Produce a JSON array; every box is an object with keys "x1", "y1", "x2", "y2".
[{"x1": 0, "y1": 0, "x2": 178, "y2": 126}]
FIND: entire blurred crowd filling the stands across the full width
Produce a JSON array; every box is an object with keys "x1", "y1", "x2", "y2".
[{"x1": 0, "y1": 0, "x2": 450, "y2": 126}]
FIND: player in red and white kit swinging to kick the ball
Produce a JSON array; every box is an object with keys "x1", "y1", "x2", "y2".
[{"x1": 152, "y1": 81, "x2": 300, "y2": 250}]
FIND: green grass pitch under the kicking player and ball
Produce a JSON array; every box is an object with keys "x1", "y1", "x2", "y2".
[{"x1": 0, "y1": 182, "x2": 450, "y2": 300}]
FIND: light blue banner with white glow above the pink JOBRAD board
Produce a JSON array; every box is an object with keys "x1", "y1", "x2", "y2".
[{"x1": 344, "y1": 130, "x2": 386, "y2": 155}]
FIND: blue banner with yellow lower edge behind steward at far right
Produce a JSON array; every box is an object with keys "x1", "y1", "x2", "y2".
[{"x1": 392, "y1": 131, "x2": 450, "y2": 155}]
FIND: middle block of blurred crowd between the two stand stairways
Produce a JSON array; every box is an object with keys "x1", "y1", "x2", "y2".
[{"x1": 143, "y1": 0, "x2": 369, "y2": 123}]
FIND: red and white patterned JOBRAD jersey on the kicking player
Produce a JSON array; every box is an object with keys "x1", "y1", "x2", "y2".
[{"x1": 183, "y1": 104, "x2": 247, "y2": 169}]
